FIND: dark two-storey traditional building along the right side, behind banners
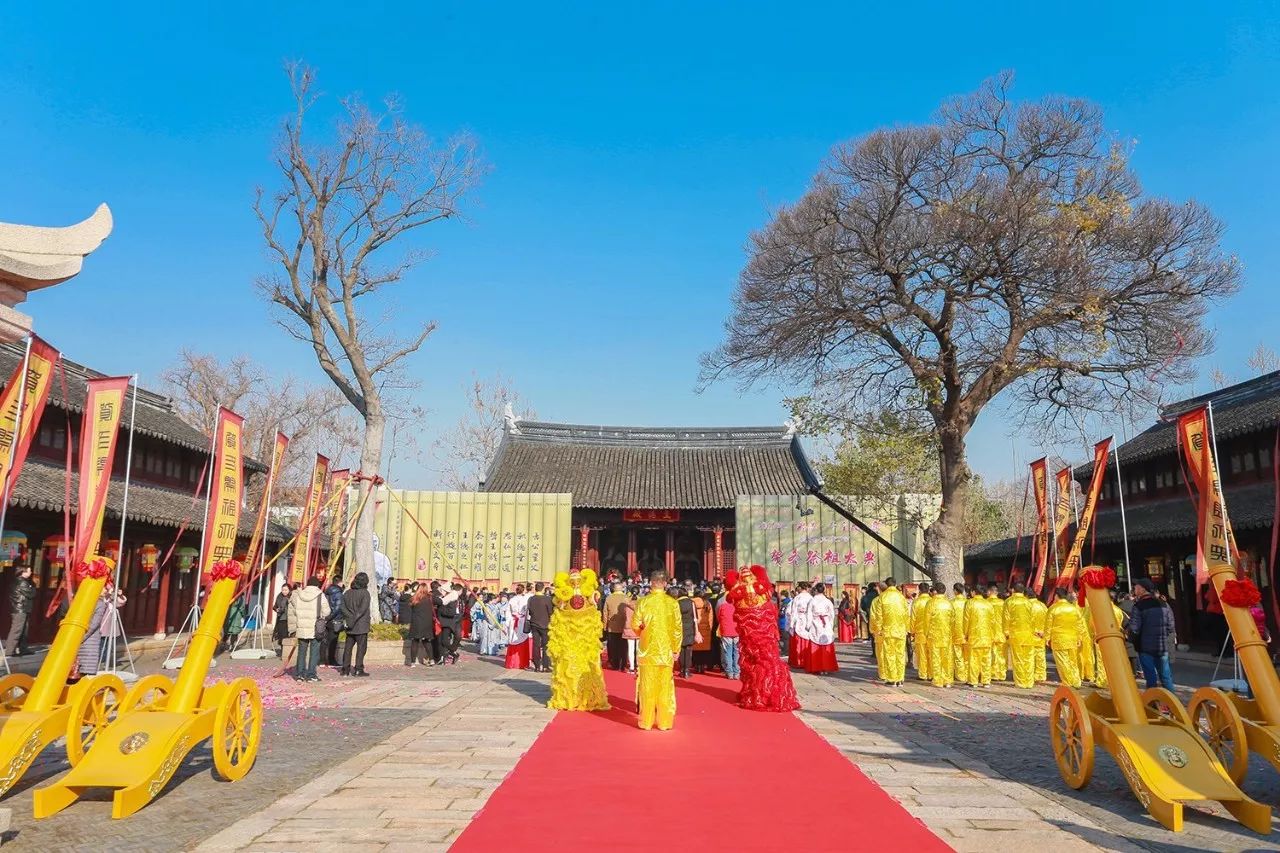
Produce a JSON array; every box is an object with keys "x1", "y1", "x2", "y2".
[{"x1": 965, "y1": 371, "x2": 1280, "y2": 644}]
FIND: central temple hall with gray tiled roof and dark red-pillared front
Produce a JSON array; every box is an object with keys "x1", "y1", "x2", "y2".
[{"x1": 481, "y1": 419, "x2": 820, "y2": 579}]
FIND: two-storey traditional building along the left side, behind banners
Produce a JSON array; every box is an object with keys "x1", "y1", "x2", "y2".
[{"x1": 0, "y1": 343, "x2": 287, "y2": 640}]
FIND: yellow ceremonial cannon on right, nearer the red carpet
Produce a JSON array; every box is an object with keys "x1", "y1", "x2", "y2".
[{"x1": 1050, "y1": 566, "x2": 1271, "y2": 835}]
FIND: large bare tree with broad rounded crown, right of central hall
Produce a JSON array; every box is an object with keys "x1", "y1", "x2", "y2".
[{"x1": 703, "y1": 74, "x2": 1240, "y2": 583}]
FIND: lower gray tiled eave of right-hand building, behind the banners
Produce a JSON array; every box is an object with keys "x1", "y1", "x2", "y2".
[{"x1": 964, "y1": 483, "x2": 1275, "y2": 562}]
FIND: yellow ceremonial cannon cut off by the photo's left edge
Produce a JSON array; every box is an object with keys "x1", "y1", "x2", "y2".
[{"x1": 0, "y1": 557, "x2": 124, "y2": 794}]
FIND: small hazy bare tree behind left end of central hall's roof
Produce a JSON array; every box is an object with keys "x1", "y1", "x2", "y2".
[{"x1": 431, "y1": 374, "x2": 538, "y2": 491}]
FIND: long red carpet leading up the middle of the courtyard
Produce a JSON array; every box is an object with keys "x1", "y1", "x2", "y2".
[{"x1": 452, "y1": 671, "x2": 950, "y2": 853}]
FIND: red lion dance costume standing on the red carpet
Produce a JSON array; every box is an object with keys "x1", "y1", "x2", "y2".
[{"x1": 726, "y1": 566, "x2": 800, "y2": 711}]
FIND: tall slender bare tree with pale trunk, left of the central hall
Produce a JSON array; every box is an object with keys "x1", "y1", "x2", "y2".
[{"x1": 253, "y1": 63, "x2": 481, "y2": 620}]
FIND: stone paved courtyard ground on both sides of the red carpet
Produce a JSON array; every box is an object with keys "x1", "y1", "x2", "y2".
[{"x1": 4, "y1": 637, "x2": 1280, "y2": 853}]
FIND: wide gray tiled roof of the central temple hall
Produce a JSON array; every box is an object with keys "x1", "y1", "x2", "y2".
[{"x1": 484, "y1": 421, "x2": 819, "y2": 510}]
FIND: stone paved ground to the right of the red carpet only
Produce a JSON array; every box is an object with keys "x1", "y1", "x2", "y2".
[{"x1": 797, "y1": 646, "x2": 1280, "y2": 853}]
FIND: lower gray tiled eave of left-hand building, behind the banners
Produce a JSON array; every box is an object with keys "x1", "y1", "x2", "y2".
[{"x1": 9, "y1": 459, "x2": 292, "y2": 540}]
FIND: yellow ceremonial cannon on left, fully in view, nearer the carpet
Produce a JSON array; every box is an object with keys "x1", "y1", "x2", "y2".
[{"x1": 35, "y1": 561, "x2": 262, "y2": 818}]
